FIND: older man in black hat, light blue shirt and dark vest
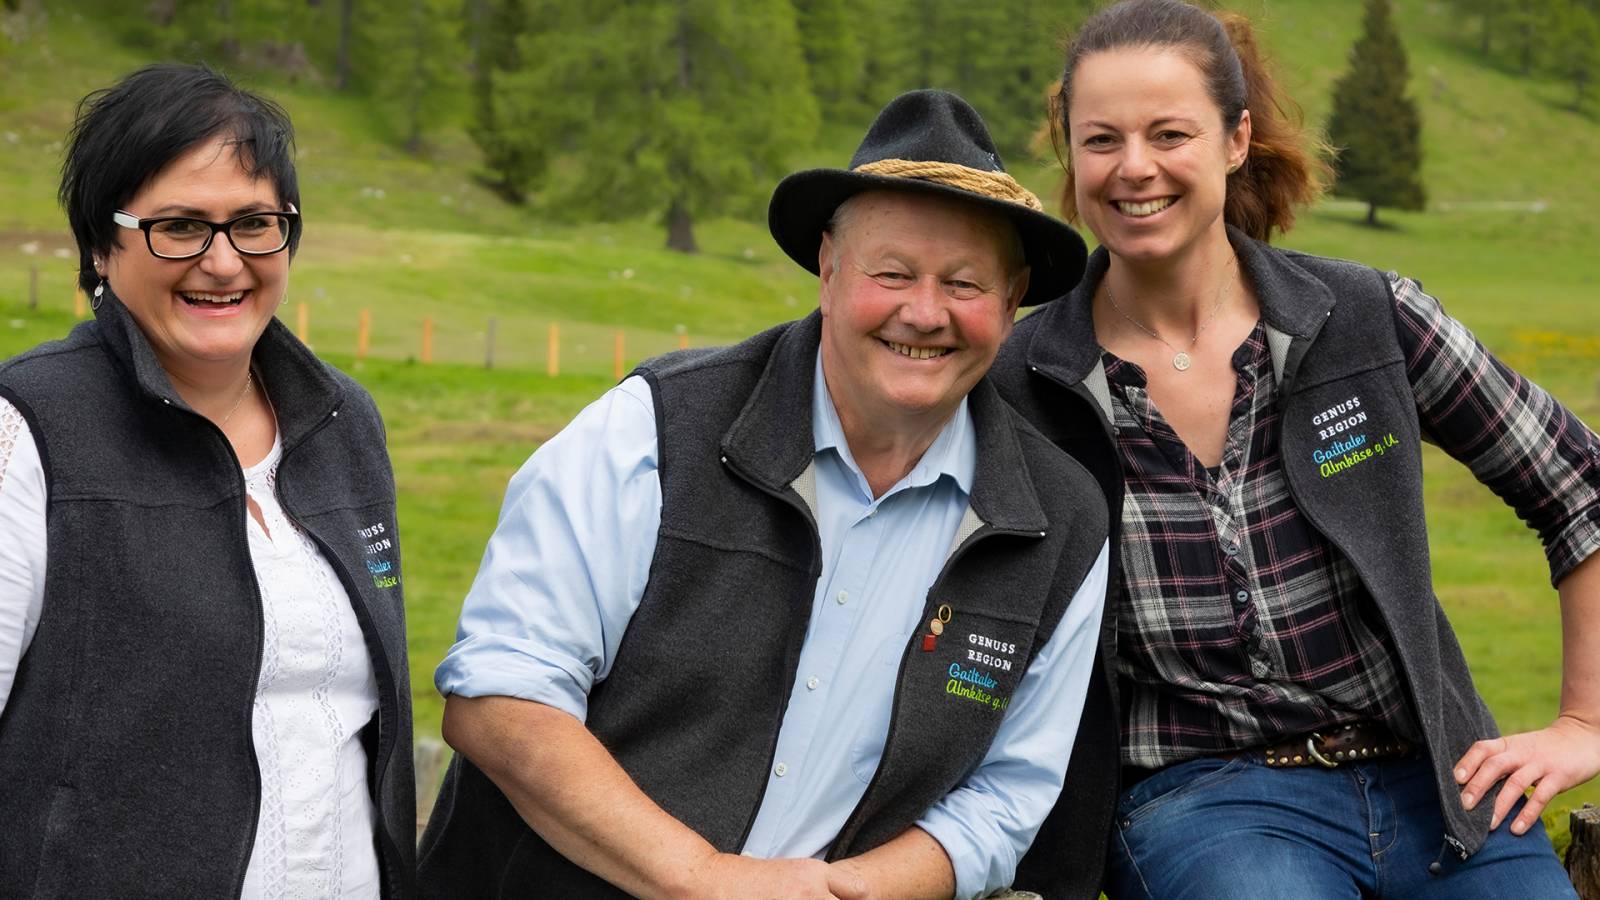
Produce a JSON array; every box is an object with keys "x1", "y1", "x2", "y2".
[{"x1": 421, "y1": 91, "x2": 1107, "y2": 900}]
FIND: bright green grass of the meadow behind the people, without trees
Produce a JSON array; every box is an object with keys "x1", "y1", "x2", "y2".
[{"x1": 0, "y1": 0, "x2": 1600, "y2": 831}]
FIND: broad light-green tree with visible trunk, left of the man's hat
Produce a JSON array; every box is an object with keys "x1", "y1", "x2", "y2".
[{"x1": 491, "y1": 0, "x2": 818, "y2": 253}]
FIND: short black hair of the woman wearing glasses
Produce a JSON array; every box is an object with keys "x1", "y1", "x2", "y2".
[{"x1": 59, "y1": 62, "x2": 301, "y2": 291}]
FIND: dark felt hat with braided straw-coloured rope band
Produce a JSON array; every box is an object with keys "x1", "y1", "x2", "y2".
[{"x1": 766, "y1": 90, "x2": 1088, "y2": 306}]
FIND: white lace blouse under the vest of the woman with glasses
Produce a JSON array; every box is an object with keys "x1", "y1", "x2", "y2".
[{"x1": 0, "y1": 399, "x2": 379, "y2": 900}]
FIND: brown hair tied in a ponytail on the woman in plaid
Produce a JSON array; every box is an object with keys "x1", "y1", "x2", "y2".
[{"x1": 1051, "y1": 0, "x2": 1330, "y2": 240}]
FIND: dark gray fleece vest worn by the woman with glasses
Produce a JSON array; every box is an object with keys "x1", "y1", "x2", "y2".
[{"x1": 0, "y1": 295, "x2": 416, "y2": 900}]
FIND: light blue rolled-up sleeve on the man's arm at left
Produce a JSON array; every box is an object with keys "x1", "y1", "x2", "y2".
[{"x1": 434, "y1": 376, "x2": 661, "y2": 721}]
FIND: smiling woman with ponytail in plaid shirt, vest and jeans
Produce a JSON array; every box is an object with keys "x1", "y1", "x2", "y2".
[{"x1": 994, "y1": 0, "x2": 1600, "y2": 900}]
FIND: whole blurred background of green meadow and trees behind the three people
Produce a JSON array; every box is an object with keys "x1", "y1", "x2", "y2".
[{"x1": 0, "y1": 0, "x2": 1600, "y2": 844}]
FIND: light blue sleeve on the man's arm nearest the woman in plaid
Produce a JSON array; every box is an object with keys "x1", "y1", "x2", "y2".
[{"x1": 917, "y1": 543, "x2": 1110, "y2": 898}]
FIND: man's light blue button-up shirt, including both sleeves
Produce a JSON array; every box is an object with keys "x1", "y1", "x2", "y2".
[{"x1": 435, "y1": 353, "x2": 1109, "y2": 897}]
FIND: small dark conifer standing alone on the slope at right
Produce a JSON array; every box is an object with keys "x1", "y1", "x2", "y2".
[{"x1": 1328, "y1": 0, "x2": 1427, "y2": 224}]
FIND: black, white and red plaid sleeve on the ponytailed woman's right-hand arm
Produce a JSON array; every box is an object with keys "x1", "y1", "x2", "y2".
[{"x1": 1389, "y1": 274, "x2": 1600, "y2": 585}]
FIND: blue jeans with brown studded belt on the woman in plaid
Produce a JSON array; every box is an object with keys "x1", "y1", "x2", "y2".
[{"x1": 1106, "y1": 757, "x2": 1578, "y2": 900}]
